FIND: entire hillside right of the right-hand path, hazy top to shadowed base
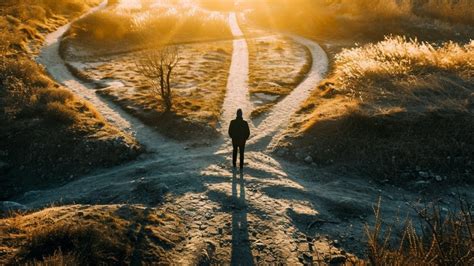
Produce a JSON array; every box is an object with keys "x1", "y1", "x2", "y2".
[{"x1": 247, "y1": 0, "x2": 474, "y2": 183}]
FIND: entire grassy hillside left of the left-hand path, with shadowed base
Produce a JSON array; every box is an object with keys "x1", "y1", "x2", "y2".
[{"x1": 0, "y1": 0, "x2": 138, "y2": 199}]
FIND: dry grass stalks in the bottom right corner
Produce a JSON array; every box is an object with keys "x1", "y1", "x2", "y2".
[{"x1": 366, "y1": 196, "x2": 474, "y2": 265}]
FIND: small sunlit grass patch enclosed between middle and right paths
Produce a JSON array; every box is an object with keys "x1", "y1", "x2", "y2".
[{"x1": 247, "y1": 37, "x2": 312, "y2": 117}]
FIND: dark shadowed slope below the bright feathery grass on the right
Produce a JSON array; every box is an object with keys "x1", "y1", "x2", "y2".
[{"x1": 279, "y1": 107, "x2": 474, "y2": 184}]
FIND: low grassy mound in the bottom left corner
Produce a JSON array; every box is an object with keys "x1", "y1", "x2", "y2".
[{"x1": 0, "y1": 205, "x2": 184, "y2": 265}]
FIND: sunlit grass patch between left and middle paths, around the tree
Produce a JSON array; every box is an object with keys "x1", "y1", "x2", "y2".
[{"x1": 63, "y1": 41, "x2": 232, "y2": 139}]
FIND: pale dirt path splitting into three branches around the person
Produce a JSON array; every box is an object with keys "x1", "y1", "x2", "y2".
[{"x1": 23, "y1": 2, "x2": 474, "y2": 265}]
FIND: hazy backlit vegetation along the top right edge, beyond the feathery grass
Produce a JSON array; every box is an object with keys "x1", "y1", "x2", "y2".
[{"x1": 247, "y1": 0, "x2": 474, "y2": 42}]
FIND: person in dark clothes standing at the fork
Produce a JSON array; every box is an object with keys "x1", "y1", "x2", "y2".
[{"x1": 229, "y1": 109, "x2": 250, "y2": 169}]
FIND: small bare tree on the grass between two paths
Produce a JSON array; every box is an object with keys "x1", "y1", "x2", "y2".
[{"x1": 137, "y1": 46, "x2": 180, "y2": 112}]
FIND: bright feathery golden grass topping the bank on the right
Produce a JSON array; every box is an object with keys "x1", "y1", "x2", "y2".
[{"x1": 333, "y1": 36, "x2": 474, "y2": 106}]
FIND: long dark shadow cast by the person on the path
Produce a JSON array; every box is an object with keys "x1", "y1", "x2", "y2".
[{"x1": 231, "y1": 170, "x2": 253, "y2": 265}]
